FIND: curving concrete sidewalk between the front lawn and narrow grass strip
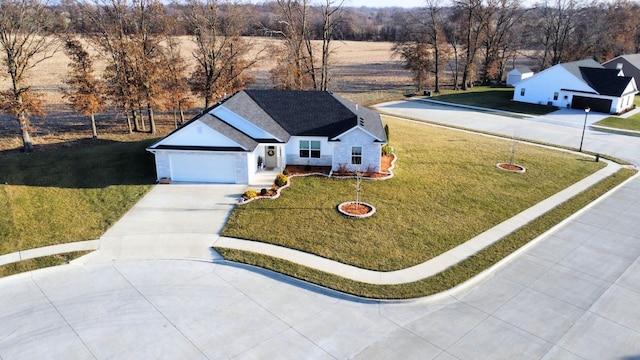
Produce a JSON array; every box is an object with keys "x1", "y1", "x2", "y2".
[{"x1": 213, "y1": 161, "x2": 620, "y2": 285}]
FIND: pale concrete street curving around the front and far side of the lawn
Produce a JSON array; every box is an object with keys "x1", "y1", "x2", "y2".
[{"x1": 0, "y1": 102, "x2": 640, "y2": 359}]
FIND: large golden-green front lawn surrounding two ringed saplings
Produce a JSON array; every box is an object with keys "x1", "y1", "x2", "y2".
[{"x1": 223, "y1": 118, "x2": 604, "y2": 271}]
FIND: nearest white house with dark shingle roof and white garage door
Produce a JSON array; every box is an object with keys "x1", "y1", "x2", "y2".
[{"x1": 147, "y1": 90, "x2": 387, "y2": 184}]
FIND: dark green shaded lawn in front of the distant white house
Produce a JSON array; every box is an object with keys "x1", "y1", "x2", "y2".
[{"x1": 433, "y1": 86, "x2": 557, "y2": 115}]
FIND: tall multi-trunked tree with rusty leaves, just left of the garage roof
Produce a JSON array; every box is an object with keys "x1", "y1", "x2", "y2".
[{"x1": 74, "y1": 0, "x2": 169, "y2": 134}]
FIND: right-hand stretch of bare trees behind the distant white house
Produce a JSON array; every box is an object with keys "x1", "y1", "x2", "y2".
[{"x1": 394, "y1": 0, "x2": 640, "y2": 92}]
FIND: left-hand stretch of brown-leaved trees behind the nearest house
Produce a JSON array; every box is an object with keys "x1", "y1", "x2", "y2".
[{"x1": 0, "y1": 0, "x2": 342, "y2": 152}]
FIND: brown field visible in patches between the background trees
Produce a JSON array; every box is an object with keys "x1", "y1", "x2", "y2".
[{"x1": 0, "y1": 37, "x2": 411, "y2": 151}]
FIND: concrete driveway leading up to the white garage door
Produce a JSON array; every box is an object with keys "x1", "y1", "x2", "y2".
[{"x1": 77, "y1": 184, "x2": 247, "y2": 264}]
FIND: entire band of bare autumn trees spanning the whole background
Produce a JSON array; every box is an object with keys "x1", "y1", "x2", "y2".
[{"x1": 0, "y1": 0, "x2": 640, "y2": 152}]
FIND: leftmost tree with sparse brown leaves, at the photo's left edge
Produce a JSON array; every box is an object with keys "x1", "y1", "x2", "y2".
[{"x1": 0, "y1": 0, "x2": 59, "y2": 152}]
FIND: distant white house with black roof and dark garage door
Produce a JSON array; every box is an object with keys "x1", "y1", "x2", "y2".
[{"x1": 513, "y1": 59, "x2": 638, "y2": 113}]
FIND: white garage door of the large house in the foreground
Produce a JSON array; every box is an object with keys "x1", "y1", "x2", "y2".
[{"x1": 171, "y1": 153, "x2": 236, "y2": 184}]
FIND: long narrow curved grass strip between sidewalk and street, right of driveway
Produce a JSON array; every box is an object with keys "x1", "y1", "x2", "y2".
[{"x1": 216, "y1": 169, "x2": 636, "y2": 299}]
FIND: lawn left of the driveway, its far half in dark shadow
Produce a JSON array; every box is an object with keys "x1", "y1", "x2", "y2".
[{"x1": 0, "y1": 140, "x2": 155, "y2": 254}]
